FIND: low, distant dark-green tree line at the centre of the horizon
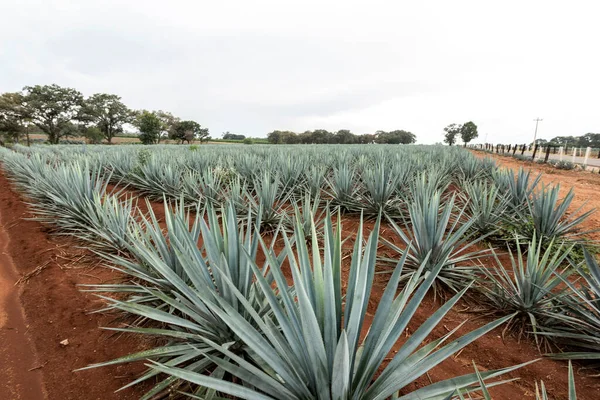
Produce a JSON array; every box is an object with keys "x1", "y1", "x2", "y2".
[{"x1": 267, "y1": 129, "x2": 417, "y2": 144}]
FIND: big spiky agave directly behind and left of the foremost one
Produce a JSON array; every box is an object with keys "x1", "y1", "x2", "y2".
[{"x1": 79, "y1": 201, "x2": 292, "y2": 399}]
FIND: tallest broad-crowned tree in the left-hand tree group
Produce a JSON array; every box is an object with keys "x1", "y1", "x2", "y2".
[{"x1": 23, "y1": 84, "x2": 83, "y2": 144}]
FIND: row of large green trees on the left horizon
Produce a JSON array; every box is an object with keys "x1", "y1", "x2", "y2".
[{"x1": 0, "y1": 84, "x2": 209, "y2": 144}]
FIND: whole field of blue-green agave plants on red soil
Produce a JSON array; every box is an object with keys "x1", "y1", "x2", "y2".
[{"x1": 0, "y1": 145, "x2": 600, "y2": 400}]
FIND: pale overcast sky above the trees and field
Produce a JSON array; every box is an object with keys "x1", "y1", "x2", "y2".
[{"x1": 0, "y1": 0, "x2": 600, "y2": 143}]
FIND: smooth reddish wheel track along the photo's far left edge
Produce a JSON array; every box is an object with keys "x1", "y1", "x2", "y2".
[{"x1": 0, "y1": 205, "x2": 47, "y2": 400}]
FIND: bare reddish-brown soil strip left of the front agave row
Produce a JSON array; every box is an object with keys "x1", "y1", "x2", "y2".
[{"x1": 0, "y1": 169, "x2": 148, "y2": 400}]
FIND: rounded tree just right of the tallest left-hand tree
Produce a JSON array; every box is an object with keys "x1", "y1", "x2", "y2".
[{"x1": 81, "y1": 93, "x2": 132, "y2": 143}]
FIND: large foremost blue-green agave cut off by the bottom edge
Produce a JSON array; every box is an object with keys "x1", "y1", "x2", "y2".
[{"x1": 151, "y1": 211, "x2": 519, "y2": 400}]
